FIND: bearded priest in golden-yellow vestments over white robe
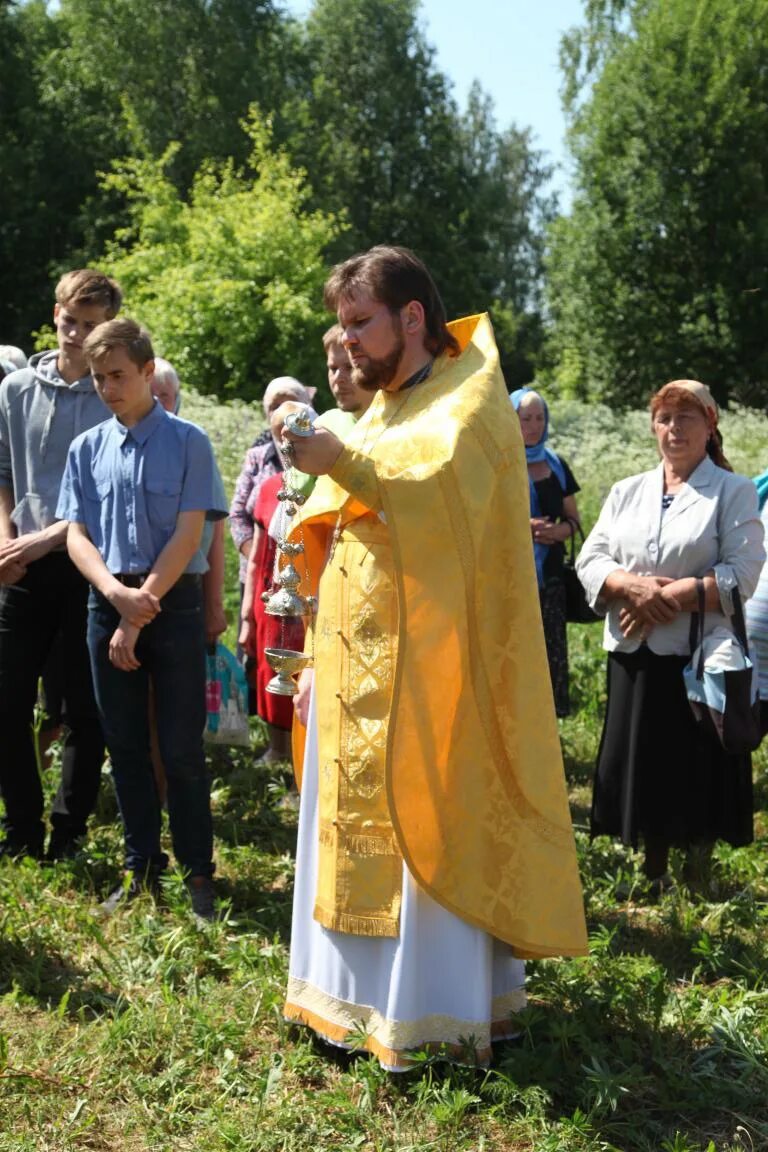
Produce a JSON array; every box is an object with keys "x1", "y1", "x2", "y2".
[{"x1": 286, "y1": 247, "x2": 586, "y2": 1068}]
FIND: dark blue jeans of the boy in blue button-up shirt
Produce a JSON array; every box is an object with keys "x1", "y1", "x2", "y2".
[{"x1": 88, "y1": 577, "x2": 213, "y2": 876}]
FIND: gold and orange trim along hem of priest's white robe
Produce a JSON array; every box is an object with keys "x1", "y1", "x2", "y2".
[{"x1": 283, "y1": 977, "x2": 526, "y2": 1071}]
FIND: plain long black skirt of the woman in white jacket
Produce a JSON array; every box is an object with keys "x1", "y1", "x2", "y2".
[{"x1": 592, "y1": 646, "x2": 753, "y2": 848}]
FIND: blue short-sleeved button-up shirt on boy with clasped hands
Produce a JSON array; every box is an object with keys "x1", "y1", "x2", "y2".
[{"x1": 56, "y1": 401, "x2": 228, "y2": 573}]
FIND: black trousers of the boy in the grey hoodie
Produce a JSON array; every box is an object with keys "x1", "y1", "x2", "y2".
[{"x1": 0, "y1": 552, "x2": 104, "y2": 850}]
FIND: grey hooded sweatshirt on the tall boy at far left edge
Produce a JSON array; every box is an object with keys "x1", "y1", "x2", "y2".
[{"x1": 0, "y1": 349, "x2": 112, "y2": 536}]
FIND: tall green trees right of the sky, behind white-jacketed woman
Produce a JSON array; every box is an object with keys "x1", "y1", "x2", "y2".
[{"x1": 548, "y1": 0, "x2": 768, "y2": 406}]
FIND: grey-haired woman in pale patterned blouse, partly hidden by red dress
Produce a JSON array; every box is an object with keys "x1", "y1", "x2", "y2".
[{"x1": 229, "y1": 376, "x2": 317, "y2": 715}]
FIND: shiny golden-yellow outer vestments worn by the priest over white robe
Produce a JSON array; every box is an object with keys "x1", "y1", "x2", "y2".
[{"x1": 295, "y1": 316, "x2": 587, "y2": 956}]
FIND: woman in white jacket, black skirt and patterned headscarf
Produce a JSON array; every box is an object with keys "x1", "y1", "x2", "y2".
[{"x1": 577, "y1": 380, "x2": 765, "y2": 894}]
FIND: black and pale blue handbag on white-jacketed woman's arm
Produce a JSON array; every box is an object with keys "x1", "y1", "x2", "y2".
[{"x1": 683, "y1": 579, "x2": 762, "y2": 753}]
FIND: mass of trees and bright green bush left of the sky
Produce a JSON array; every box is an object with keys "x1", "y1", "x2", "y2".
[{"x1": 0, "y1": 0, "x2": 552, "y2": 395}]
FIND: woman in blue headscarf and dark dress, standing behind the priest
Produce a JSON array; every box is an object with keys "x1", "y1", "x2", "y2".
[{"x1": 510, "y1": 388, "x2": 579, "y2": 717}]
